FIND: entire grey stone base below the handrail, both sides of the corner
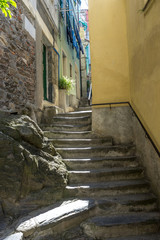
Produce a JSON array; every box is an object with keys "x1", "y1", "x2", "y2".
[{"x1": 92, "y1": 106, "x2": 160, "y2": 202}]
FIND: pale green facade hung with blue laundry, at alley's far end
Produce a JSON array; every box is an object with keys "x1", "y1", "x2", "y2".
[{"x1": 58, "y1": 0, "x2": 83, "y2": 107}]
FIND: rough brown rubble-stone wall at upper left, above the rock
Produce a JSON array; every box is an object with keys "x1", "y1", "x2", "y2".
[{"x1": 0, "y1": 1, "x2": 36, "y2": 112}]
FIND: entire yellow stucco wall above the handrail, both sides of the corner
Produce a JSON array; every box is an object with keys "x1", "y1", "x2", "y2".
[{"x1": 89, "y1": 0, "x2": 160, "y2": 150}]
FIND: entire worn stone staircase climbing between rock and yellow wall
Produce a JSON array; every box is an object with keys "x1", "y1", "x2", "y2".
[{"x1": 3, "y1": 108, "x2": 160, "y2": 240}]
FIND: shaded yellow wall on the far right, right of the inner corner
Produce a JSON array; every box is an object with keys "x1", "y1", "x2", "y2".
[{"x1": 126, "y1": 0, "x2": 160, "y2": 150}]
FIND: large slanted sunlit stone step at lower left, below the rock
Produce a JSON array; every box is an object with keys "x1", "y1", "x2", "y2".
[{"x1": 12, "y1": 199, "x2": 96, "y2": 240}]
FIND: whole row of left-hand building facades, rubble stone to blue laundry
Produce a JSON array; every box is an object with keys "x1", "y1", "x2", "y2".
[{"x1": 0, "y1": 0, "x2": 81, "y2": 121}]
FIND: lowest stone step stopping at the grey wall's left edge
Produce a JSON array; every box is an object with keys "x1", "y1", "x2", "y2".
[{"x1": 44, "y1": 131, "x2": 93, "y2": 139}]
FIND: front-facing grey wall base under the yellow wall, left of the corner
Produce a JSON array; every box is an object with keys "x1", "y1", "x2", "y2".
[{"x1": 92, "y1": 106, "x2": 134, "y2": 144}]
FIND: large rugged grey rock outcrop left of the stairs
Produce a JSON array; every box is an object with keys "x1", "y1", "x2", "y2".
[{"x1": 0, "y1": 114, "x2": 67, "y2": 225}]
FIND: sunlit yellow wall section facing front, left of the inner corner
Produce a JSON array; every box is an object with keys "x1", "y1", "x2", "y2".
[{"x1": 89, "y1": 0, "x2": 130, "y2": 104}]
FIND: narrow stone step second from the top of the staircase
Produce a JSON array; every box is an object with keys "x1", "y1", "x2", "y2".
[{"x1": 52, "y1": 115, "x2": 91, "y2": 125}]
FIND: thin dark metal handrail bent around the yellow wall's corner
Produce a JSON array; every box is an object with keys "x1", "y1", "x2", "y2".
[{"x1": 91, "y1": 102, "x2": 160, "y2": 157}]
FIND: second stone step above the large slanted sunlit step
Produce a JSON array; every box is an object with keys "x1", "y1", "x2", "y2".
[{"x1": 69, "y1": 167, "x2": 144, "y2": 184}]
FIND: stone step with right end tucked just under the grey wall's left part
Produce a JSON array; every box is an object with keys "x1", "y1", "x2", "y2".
[{"x1": 49, "y1": 137, "x2": 112, "y2": 148}]
